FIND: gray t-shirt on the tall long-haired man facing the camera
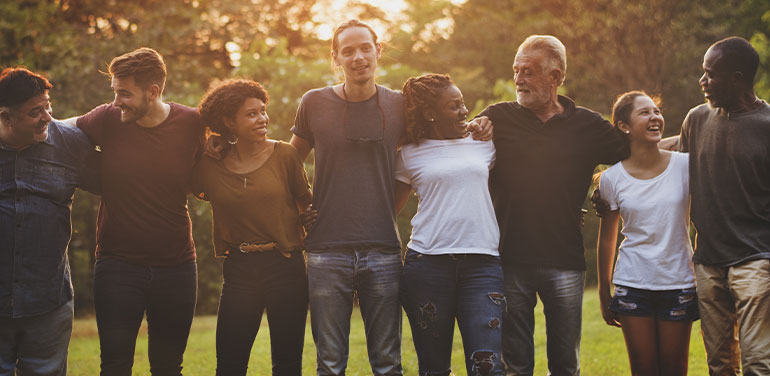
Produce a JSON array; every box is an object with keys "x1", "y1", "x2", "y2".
[{"x1": 291, "y1": 86, "x2": 405, "y2": 251}]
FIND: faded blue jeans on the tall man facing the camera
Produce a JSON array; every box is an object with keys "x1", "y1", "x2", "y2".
[{"x1": 307, "y1": 247, "x2": 402, "y2": 376}]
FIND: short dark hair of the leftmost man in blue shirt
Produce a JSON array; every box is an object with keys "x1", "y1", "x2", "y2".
[{"x1": 0, "y1": 67, "x2": 53, "y2": 108}]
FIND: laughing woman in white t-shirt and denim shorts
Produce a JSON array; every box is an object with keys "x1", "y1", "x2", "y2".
[{"x1": 598, "y1": 91, "x2": 698, "y2": 375}]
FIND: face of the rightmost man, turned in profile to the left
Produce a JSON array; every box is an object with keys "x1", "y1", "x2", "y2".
[{"x1": 698, "y1": 48, "x2": 738, "y2": 109}]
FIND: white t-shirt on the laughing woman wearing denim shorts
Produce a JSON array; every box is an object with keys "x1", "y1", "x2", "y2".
[{"x1": 600, "y1": 153, "x2": 695, "y2": 290}]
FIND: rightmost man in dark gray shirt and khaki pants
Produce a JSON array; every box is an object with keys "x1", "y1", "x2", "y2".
[{"x1": 679, "y1": 37, "x2": 770, "y2": 375}]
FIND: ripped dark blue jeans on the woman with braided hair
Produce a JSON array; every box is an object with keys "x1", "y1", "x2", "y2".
[{"x1": 401, "y1": 250, "x2": 505, "y2": 376}]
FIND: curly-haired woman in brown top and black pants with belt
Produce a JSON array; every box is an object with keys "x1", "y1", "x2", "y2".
[{"x1": 192, "y1": 80, "x2": 312, "y2": 375}]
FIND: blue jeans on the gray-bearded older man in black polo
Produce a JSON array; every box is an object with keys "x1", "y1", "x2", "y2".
[{"x1": 503, "y1": 265, "x2": 585, "y2": 375}]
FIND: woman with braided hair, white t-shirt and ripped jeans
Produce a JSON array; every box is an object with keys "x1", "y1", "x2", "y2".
[{"x1": 396, "y1": 74, "x2": 505, "y2": 375}]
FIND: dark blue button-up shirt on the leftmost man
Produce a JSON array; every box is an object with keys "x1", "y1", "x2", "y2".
[{"x1": 0, "y1": 120, "x2": 98, "y2": 318}]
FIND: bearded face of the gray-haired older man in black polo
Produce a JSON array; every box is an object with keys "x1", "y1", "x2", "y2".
[{"x1": 513, "y1": 49, "x2": 559, "y2": 112}]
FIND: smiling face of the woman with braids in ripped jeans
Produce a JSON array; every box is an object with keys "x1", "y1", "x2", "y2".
[{"x1": 425, "y1": 85, "x2": 468, "y2": 138}]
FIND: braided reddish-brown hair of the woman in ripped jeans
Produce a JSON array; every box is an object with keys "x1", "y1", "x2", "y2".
[{"x1": 401, "y1": 73, "x2": 454, "y2": 144}]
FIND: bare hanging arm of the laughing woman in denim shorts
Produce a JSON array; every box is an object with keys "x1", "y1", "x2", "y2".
[{"x1": 596, "y1": 210, "x2": 620, "y2": 327}]
